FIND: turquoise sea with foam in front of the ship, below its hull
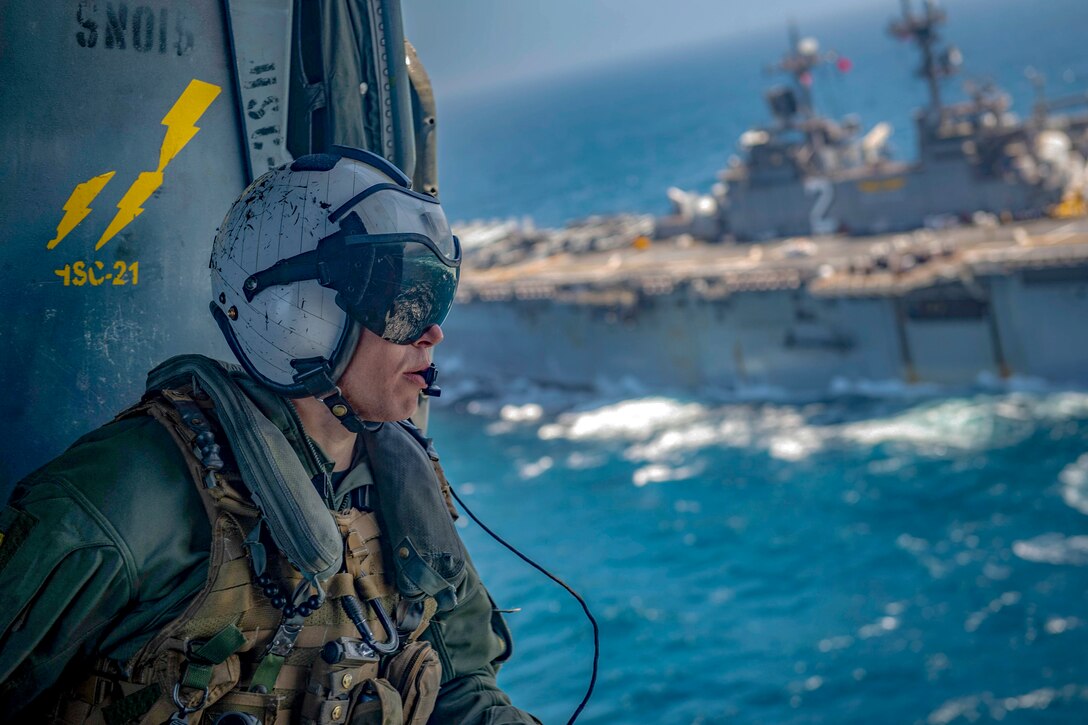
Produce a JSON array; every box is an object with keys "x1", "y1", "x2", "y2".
[{"x1": 431, "y1": 390, "x2": 1088, "y2": 725}]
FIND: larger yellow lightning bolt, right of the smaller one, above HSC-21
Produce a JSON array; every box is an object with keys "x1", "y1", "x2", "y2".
[{"x1": 95, "y1": 78, "x2": 222, "y2": 250}]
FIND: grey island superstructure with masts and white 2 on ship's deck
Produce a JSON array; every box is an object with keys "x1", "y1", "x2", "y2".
[{"x1": 659, "y1": 0, "x2": 1071, "y2": 241}]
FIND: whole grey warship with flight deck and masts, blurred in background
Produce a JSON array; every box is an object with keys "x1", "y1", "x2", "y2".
[{"x1": 443, "y1": 0, "x2": 1088, "y2": 395}]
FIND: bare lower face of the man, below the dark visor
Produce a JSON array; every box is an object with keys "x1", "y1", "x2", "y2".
[{"x1": 339, "y1": 324, "x2": 444, "y2": 422}]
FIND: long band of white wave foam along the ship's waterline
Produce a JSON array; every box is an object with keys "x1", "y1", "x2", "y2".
[{"x1": 459, "y1": 381, "x2": 1088, "y2": 468}]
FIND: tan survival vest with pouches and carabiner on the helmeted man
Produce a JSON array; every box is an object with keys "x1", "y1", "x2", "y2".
[{"x1": 46, "y1": 356, "x2": 467, "y2": 725}]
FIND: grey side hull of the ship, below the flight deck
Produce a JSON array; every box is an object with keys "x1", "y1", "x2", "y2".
[{"x1": 440, "y1": 222, "x2": 1088, "y2": 395}]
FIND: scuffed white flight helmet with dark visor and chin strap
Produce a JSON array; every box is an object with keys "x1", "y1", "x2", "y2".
[{"x1": 210, "y1": 146, "x2": 460, "y2": 428}]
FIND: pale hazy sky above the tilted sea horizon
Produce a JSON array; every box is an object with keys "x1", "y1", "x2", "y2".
[{"x1": 401, "y1": 0, "x2": 920, "y2": 97}]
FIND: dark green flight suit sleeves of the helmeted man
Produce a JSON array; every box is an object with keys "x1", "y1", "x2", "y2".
[{"x1": 0, "y1": 370, "x2": 539, "y2": 725}]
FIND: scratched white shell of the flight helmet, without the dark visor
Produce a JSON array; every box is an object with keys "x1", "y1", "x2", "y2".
[{"x1": 210, "y1": 147, "x2": 459, "y2": 397}]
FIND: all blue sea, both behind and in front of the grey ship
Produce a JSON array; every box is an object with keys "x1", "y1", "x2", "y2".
[{"x1": 419, "y1": 0, "x2": 1088, "y2": 725}]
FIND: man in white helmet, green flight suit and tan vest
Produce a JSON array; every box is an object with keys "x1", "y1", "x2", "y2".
[{"x1": 0, "y1": 147, "x2": 539, "y2": 725}]
